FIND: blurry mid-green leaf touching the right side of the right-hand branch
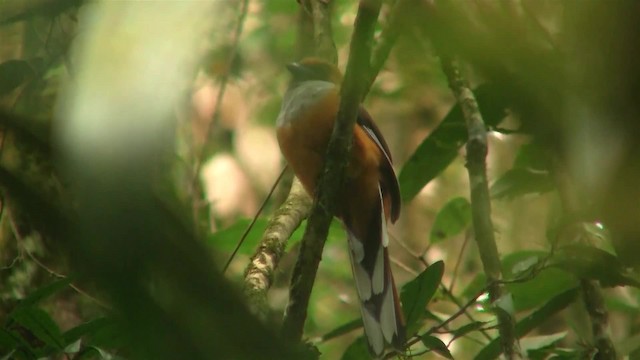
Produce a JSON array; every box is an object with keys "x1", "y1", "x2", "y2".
[{"x1": 490, "y1": 168, "x2": 555, "y2": 199}]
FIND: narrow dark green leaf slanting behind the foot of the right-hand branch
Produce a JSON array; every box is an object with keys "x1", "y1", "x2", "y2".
[{"x1": 474, "y1": 288, "x2": 580, "y2": 360}]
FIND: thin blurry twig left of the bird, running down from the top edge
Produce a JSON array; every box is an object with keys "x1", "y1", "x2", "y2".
[{"x1": 191, "y1": 0, "x2": 249, "y2": 230}]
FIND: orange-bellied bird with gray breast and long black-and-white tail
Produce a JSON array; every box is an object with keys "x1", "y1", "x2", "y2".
[{"x1": 276, "y1": 58, "x2": 405, "y2": 357}]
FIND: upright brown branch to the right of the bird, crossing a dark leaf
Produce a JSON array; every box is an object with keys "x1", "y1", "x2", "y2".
[{"x1": 442, "y1": 56, "x2": 522, "y2": 359}]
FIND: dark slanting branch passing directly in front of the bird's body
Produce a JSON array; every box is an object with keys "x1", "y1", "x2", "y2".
[{"x1": 282, "y1": 0, "x2": 382, "y2": 342}]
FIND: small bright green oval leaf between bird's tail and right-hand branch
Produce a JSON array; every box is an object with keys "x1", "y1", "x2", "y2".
[{"x1": 429, "y1": 197, "x2": 471, "y2": 244}]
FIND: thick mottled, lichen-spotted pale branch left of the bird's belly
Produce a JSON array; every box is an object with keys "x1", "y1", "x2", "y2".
[{"x1": 244, "y1": 178, "x2": 312, "y2": 316}]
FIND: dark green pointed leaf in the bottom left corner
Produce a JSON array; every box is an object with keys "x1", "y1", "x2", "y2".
[{"x1": 10, "y1": 307, "x2": 65, "y2": 350}]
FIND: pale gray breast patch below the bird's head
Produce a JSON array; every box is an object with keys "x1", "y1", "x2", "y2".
[{"x1": 276, "y1": 80, "x2": 335, "y2": 127}]
